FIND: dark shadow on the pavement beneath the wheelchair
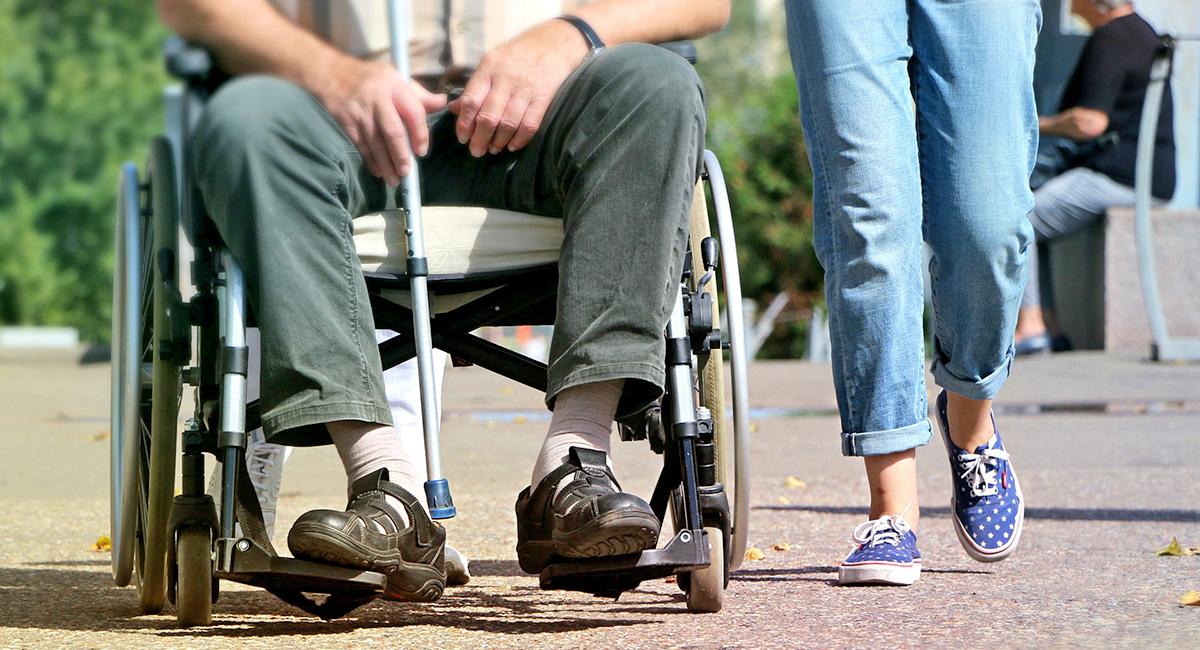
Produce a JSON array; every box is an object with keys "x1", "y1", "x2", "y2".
[{"x1": 0, "y1": 560, "x2": 676, "y2": 639}]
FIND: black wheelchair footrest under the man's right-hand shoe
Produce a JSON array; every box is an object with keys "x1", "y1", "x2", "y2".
[{"x1": 540, "y1": 530, "x2": 710, "y2": 598}]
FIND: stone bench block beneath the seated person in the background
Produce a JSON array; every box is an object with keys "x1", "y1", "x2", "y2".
[{"x1": 1048, "y1": 207, "x2": 1200, "y2": 357}]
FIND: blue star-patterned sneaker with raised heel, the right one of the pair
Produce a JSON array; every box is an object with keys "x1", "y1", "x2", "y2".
[{"x1": 937, "y1": 391, "x2": 1025, "y2": 562}]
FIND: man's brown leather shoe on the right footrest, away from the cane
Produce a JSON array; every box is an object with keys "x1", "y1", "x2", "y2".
[{"x1": 516, "y1": 447, "x2": 661, "y2": 573}]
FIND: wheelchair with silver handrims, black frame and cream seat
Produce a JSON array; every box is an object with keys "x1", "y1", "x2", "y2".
[{"x1": 110, "y1": 35, "x2": 750, "y2": 626}]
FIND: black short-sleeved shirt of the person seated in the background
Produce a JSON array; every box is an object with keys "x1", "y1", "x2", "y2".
[{"x1": 1060, "y1": 13, "x2": 1175, "y2": 199}]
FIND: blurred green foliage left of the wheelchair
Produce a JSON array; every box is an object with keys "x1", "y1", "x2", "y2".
[{"x1": 0, "y1": 0, "x2": 167, "y2": 341}]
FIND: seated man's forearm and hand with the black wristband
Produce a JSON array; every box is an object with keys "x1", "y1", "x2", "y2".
[{"x1": 450, "y1": 0, "x2": 730, "y2": 156}]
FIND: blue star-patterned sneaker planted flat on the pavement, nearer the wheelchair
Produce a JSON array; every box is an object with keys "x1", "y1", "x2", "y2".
[{"x1": 838, "y1": 514, "x2": 920, "y2": 585}]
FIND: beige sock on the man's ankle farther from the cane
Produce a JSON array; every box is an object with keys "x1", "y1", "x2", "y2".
[{"x1": 529, "y1": 379, "x2": 625, "y2": 488}]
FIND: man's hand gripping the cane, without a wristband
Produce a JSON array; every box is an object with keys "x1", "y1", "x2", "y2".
[{"x1": 317, "y1": 59, "x2": 446, "y2": 186}]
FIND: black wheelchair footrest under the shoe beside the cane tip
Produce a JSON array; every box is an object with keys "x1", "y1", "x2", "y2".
[{"x1": 212, "y1": 537, "x2": 388, "y2": 620}]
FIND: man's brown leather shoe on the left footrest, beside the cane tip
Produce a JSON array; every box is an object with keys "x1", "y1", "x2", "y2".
[{"x1": 288, "y1": 468, "x2": 446, "y2": 602}]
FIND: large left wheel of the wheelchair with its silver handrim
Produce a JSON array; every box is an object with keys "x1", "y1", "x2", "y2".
[{"x1": 112, "y1": 137, "x2": 181, "y2": 614}]
